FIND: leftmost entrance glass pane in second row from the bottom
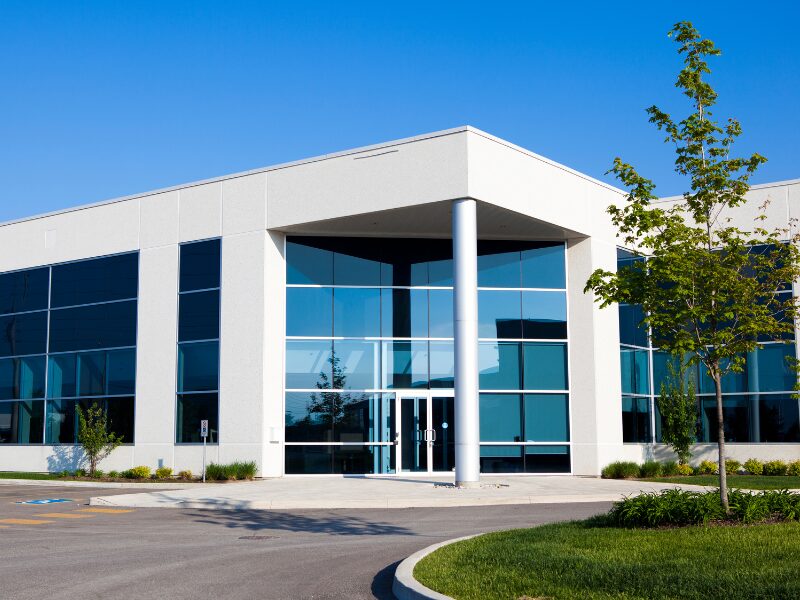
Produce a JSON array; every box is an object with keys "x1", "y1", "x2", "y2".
[{"x1": 285, "y1": 392, "x2": 340, "y2": 442}]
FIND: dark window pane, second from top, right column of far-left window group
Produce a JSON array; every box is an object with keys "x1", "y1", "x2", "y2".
[{"x1": 50, "y1": 300, "x2": 136, "y2": 352}]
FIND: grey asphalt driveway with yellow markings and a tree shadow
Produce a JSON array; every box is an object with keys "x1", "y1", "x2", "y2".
[{"x1": 0, "y1": 485, "x2": 610, "y2": 600}]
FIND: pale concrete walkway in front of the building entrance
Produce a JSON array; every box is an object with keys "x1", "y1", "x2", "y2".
[{"x1": 91, "y1": 476, "x2": 706, "y2": 510}]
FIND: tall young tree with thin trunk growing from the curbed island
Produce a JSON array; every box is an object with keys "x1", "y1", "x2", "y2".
[{"x1": 586, "y1": 21, "x2": 800, "y2": 512}]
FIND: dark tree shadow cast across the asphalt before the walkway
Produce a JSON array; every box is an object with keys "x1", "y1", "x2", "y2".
[{"x1": 186, "y1": 510, "x2": 417, "y2": 536}]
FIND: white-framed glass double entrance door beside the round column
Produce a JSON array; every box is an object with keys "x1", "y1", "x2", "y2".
[{"x1": 397, "y1": 392, "x2": 455, "y2": 473}]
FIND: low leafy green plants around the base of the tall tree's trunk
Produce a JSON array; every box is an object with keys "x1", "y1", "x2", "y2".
[{"x1": 608, "y1": 489, "x2": 800, "y2": 527}]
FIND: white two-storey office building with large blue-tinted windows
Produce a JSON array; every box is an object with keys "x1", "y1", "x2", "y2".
[{"x1": 0, "y1": 127, "x2": 800, "y2": 476}]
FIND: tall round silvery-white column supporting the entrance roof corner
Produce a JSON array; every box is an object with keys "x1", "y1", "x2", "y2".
[{"x1": 453, "y1": 199, "x2": 480, "y2": 487}]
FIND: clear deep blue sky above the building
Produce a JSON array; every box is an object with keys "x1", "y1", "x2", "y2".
[{"x1": 0, "y1": 0, "x2": 800, "y2": 221}]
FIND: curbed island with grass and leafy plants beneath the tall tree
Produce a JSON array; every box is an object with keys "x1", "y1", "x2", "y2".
[{"x1": 414, "y1": 490, "x2": 800, "y2": 600}]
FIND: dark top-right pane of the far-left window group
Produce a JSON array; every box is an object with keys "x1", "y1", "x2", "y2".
[{"x1": 50, "y1": 253, "x2": 139, "y2": 308}]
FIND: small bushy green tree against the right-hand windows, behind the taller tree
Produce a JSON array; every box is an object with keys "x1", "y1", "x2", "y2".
[{"x1": 656, "y1": 362, "x2": 698, "y2": 465}]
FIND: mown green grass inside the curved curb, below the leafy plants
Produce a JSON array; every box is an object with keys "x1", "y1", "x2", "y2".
[{"x1": 414, "y1": 522, "x2": 800, "y2": 600}]
